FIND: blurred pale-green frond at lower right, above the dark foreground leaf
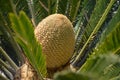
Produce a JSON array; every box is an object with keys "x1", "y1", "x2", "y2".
[{"x1": 78, "y1": 54, "x2": 120, "y2": 75}]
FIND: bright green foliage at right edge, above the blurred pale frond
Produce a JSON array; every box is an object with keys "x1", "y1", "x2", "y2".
[{"x1": 95, "y1": 7, "x2": 120, "y2": 54}]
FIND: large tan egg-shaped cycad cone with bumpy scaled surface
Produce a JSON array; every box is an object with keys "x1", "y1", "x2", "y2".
[{"x1": 34, "y1": 14, "x2": 75, "y2": 69}]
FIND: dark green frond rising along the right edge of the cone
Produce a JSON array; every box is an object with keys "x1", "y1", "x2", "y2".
[{"x1": 73, "y1": 0, "x2": 96, "y2": 62}]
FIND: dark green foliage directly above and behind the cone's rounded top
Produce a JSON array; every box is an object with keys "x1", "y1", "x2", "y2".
[{"x1": 27, "y1": 0, "x2": 81, "y2": 25}]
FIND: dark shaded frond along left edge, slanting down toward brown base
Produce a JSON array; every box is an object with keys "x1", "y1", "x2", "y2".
[{"x1": 0, "y1": 0, "x2": 24, "y2": 65}]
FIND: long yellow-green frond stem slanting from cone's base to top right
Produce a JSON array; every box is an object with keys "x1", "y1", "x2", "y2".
[{"x1": 72, "y1": 0, "x2": 115, "y2": 69}]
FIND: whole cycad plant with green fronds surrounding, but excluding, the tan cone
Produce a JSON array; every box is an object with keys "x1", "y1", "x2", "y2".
[{"x1": 0, "y1": 0, "x2": 120, "y2": 80}]
